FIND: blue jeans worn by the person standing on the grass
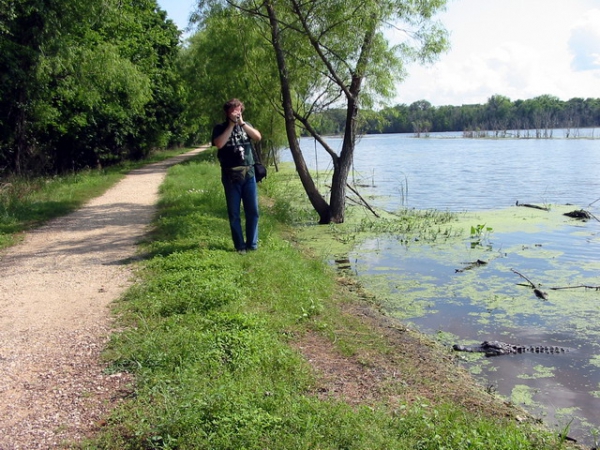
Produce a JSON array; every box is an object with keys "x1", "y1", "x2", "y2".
[{"x1": 221, "y1": 174, "x2": 258, "y2": 251}]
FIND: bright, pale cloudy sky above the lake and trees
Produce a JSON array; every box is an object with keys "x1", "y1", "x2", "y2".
[{"x1": 158, "y1": 0, "x2": 600, "y2": 106}]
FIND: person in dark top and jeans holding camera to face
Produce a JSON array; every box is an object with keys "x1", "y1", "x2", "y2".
[{"x1": 212, "y1": 98, "x2": 262, "y2": 253}]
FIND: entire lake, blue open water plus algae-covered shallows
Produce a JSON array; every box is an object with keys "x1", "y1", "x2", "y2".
[{"x1": 282, "y1": 131, "x2": 600, "y2": 446}]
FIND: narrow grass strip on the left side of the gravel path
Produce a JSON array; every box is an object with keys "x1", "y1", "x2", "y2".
[{"x1": 0, "y1": 149, "x2": 189, "y2": 249}]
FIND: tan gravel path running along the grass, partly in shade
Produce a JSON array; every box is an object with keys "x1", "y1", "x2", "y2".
[{"x1": 0, "y1": 148, "x2": 204, "y2": 450}]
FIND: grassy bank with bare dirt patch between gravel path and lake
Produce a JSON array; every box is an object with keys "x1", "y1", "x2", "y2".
[{"x1": 74, "y1": 152, "x2": 567, "y2": 450}]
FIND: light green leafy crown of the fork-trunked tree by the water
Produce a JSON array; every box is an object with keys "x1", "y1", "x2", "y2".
[{"x1": 248, "y1": 0, "x2": 448, "y2": 117}]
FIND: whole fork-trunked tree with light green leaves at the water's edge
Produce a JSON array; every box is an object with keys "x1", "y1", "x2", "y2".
[{"x1": 200, "y1": 0, "x2": 447, "y2": 223}]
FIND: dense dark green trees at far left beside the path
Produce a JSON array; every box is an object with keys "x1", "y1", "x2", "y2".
[{"x1": 0, "y1": 0, "x2": 181, "y2": 174}]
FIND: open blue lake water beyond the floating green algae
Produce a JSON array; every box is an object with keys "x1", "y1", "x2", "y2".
[{"x1": 292, "y1": 133, "x2": 600, "y2": 211}]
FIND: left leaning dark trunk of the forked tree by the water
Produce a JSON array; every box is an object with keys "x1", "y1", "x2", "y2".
[{"x1": 265, "y1": 2, "x2": 331, "y2": 224}]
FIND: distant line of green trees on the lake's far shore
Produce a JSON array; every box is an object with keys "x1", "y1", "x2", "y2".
[{"x1": 319, "y1": 95, "x2": 600, "y2": 138}]
